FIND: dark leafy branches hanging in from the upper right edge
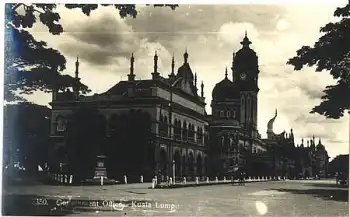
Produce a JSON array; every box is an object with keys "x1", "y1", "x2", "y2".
[{"x1": 287, "y1": 4, "x2": 350, "y2": 119}]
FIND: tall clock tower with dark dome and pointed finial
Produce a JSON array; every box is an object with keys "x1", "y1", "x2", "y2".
[{"x1": 232, "y1": 32, "x2": 259, "y2": 136}]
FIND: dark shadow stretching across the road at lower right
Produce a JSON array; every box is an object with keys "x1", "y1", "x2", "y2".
[{"x1": 270, "y1": 188, "x2": 349, "y2": 202}]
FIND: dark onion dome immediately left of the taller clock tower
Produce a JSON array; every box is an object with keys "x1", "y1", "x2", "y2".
[{"x1": 212, "y1": 76, "x2": 240, "y2": 101}]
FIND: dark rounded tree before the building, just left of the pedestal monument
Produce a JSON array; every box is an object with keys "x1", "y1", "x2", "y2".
[{"x1": 65, "y1": 107, "x2": 106, "y2": 181}]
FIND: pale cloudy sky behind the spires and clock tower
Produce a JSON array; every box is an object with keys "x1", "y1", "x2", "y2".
[{"x1": 22, "y1": 3, "x2": 349, "y2": 158}]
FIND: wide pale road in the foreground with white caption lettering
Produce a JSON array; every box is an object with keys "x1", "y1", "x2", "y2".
[{"x1": 3, "y1": 180, "x2": 349, "y2": 217}]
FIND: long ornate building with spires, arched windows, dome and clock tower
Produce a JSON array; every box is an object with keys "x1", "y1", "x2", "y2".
[{"x1": 50, "y1": 34, "x2": 328, "y2": 179}]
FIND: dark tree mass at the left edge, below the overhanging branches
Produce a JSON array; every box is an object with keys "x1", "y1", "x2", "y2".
[{"x1": 4, "y1": 103, "x2": 51, "y2": 172}]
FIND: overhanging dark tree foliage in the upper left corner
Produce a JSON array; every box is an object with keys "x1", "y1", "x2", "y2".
[{"x1": 4, "y1": 3, "x2": 177, "y2": 101}]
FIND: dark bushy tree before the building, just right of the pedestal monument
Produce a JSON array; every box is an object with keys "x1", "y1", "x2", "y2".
[{"x1": 106, "y1": 110, "x2": 155, "y2": 182}]
